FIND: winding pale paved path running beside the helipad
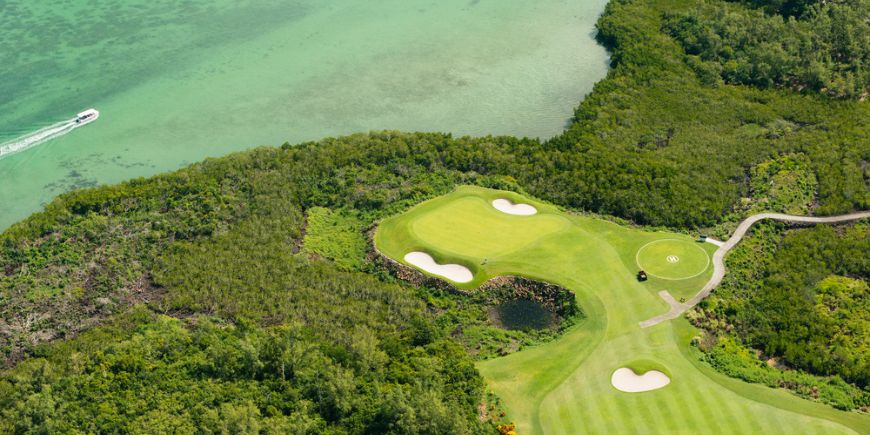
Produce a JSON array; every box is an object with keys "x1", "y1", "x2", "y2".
[{"x1": 640, "y1": 211, "x2": 870, "y2": 328}]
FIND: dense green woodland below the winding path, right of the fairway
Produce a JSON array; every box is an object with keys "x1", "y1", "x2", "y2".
[{"x1": 690, "y1": 223, "x2": 870, "y2": 409}]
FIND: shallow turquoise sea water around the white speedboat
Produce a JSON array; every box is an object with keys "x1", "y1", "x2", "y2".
[{"x1": 0, "y1": 0, "x2": 607, "y2": 229}]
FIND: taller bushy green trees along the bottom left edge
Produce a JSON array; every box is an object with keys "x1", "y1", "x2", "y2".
[{"x1": 0, "y1": 310, "x2": 485, "y2": 434}]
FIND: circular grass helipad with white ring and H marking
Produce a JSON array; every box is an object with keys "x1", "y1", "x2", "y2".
[{"x1": 636, "y1": 239, "x2": 710, "y2": 280}]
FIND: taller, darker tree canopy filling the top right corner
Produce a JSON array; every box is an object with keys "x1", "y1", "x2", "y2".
[{"x1": 665, "y1": 0, "x2": 870, "y2": 99}]
